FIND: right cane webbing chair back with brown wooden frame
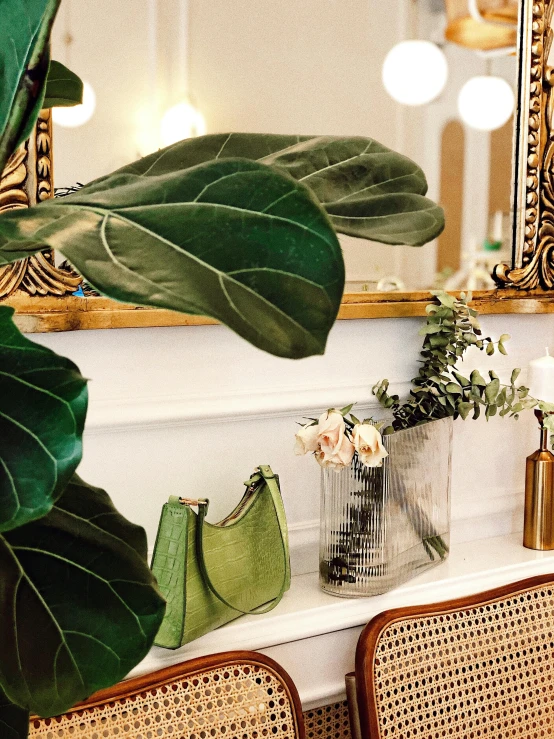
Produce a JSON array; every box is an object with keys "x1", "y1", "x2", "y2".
[{"x1": 356, "y1": 575, "x2": 554, "y2": 739}]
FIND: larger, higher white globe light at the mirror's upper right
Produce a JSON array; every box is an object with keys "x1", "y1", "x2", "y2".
[{"x1": 383, "y1": 40, "x2": 448, "y2": 105}]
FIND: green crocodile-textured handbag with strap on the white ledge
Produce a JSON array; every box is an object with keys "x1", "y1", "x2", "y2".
[{"x1": 152, "y1": 465, "x2": 290, "y2": 649}]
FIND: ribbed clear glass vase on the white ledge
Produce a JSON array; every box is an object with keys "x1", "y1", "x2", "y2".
[{"x1": 319, "y1": 418, "x2": 452, "y2": 597}]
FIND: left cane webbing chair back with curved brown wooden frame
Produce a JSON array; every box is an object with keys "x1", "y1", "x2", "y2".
[{"x1": 29, "y1": 652, "x2": 304, "y2": 739}]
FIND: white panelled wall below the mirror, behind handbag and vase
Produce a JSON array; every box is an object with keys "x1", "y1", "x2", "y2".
[{"x1": 32, "y1": 316, "x2": 554, "y2": 571}]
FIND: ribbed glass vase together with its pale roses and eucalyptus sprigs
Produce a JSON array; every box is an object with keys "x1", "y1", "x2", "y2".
[{"x1": 294, "y1": 291, "x2": 544, "y2": 595}]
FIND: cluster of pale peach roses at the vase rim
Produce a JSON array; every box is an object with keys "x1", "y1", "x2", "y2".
[{"x1": 294, "y1": 405, "x2": 388, "y2": 472}]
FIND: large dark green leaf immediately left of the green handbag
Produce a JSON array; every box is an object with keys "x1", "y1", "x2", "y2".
[{"x1": 0, "y1": 477, "x2": 165, "y2": 716}]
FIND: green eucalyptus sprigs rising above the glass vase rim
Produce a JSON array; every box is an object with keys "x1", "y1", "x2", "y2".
[{"x1": 373, "y1": 292, "x2": 537, "y2": 432}]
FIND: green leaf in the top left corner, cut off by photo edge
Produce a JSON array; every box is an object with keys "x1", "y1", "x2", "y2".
[{"x1": 0, "y1": 0, "x2": 61, "y2": 172}]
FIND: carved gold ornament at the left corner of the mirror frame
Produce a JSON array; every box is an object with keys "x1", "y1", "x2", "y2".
[{"x1": 0, "y1": 110, "x2": 82, "y2": 300}]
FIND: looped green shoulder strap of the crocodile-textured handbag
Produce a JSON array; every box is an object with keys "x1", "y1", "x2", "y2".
[{"x1": 196, "y1": 465, "x2": 289, "y2": 615}]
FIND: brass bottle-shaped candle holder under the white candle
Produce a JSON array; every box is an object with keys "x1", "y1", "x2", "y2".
[{"x1": 523, "y1": 410, "x2": 554, "y2": 551}]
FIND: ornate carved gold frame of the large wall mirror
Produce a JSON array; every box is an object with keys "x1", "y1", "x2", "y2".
[{"x1": 0, "y1": 0, "x2": 554, "y2": 333}]
